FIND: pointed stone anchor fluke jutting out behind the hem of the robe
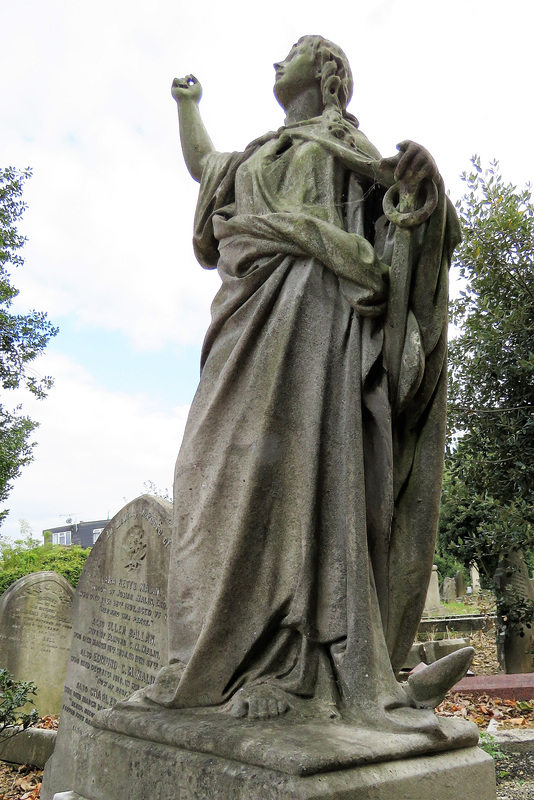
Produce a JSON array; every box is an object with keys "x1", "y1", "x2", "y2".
[{"x1": 402, "y1": 647, "x2": 475, "y2": 708}]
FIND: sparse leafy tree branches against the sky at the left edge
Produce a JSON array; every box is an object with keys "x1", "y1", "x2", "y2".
[{"x1": 0, "y1": 167, "x2": 57, "y2": 524}]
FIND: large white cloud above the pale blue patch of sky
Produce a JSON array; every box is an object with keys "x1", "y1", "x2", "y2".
[{"x1": 6, "y1": 0, "x2": 534, "y2": 348}]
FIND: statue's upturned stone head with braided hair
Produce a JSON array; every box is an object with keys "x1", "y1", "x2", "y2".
[{"x1": 274, "y1": 36, "x2": 353, "y2": 114}]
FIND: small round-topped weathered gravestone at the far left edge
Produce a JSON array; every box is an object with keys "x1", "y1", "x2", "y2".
[{"x1": 0, "y1": 572, "x2": 74, "y2": 716}]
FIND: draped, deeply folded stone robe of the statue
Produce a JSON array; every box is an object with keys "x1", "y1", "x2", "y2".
[{"x1": 163, "y1": 118, "x2": 456, "y2": 718}]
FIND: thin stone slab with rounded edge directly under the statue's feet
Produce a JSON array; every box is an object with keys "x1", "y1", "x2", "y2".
[{"x1": 90, "y1": 708, "x2": 478, "y2": 776}]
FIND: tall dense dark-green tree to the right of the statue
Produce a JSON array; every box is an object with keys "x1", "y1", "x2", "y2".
[{"x1": 439, "y1": 158, "x2": 534, "y2": 664}]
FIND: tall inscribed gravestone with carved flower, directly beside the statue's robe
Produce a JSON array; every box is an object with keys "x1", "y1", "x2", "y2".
[{"x1": 41, "y1": 495, "x2": 172, "y2": 800}]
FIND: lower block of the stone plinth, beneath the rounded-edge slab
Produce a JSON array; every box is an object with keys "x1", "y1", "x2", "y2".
[{"x1": 54, "y1": 730, "x2": 496, "y2": 800}]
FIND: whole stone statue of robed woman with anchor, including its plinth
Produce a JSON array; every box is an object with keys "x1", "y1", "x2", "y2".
[{"x1": 47, "y1": 36, "x2": 494, "y2": 800}]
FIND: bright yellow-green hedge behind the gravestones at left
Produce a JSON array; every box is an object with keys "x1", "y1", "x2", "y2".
[{"x1": 0, "y1": 538, "x2": 91, "y2": 594}]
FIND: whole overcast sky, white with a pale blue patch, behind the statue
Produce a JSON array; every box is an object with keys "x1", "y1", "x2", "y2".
[{"x1": 0, "y1": 0, "x2": 534, "y2": 538}]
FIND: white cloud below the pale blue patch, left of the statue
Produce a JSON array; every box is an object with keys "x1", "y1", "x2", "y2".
[{"x1": 1, "y1": 355, "x2": 189, "y2": 538}]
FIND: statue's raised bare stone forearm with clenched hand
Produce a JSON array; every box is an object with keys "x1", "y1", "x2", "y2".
[{"x1": 175, "y1": 75, "x2": 219, "y2": 182}]
